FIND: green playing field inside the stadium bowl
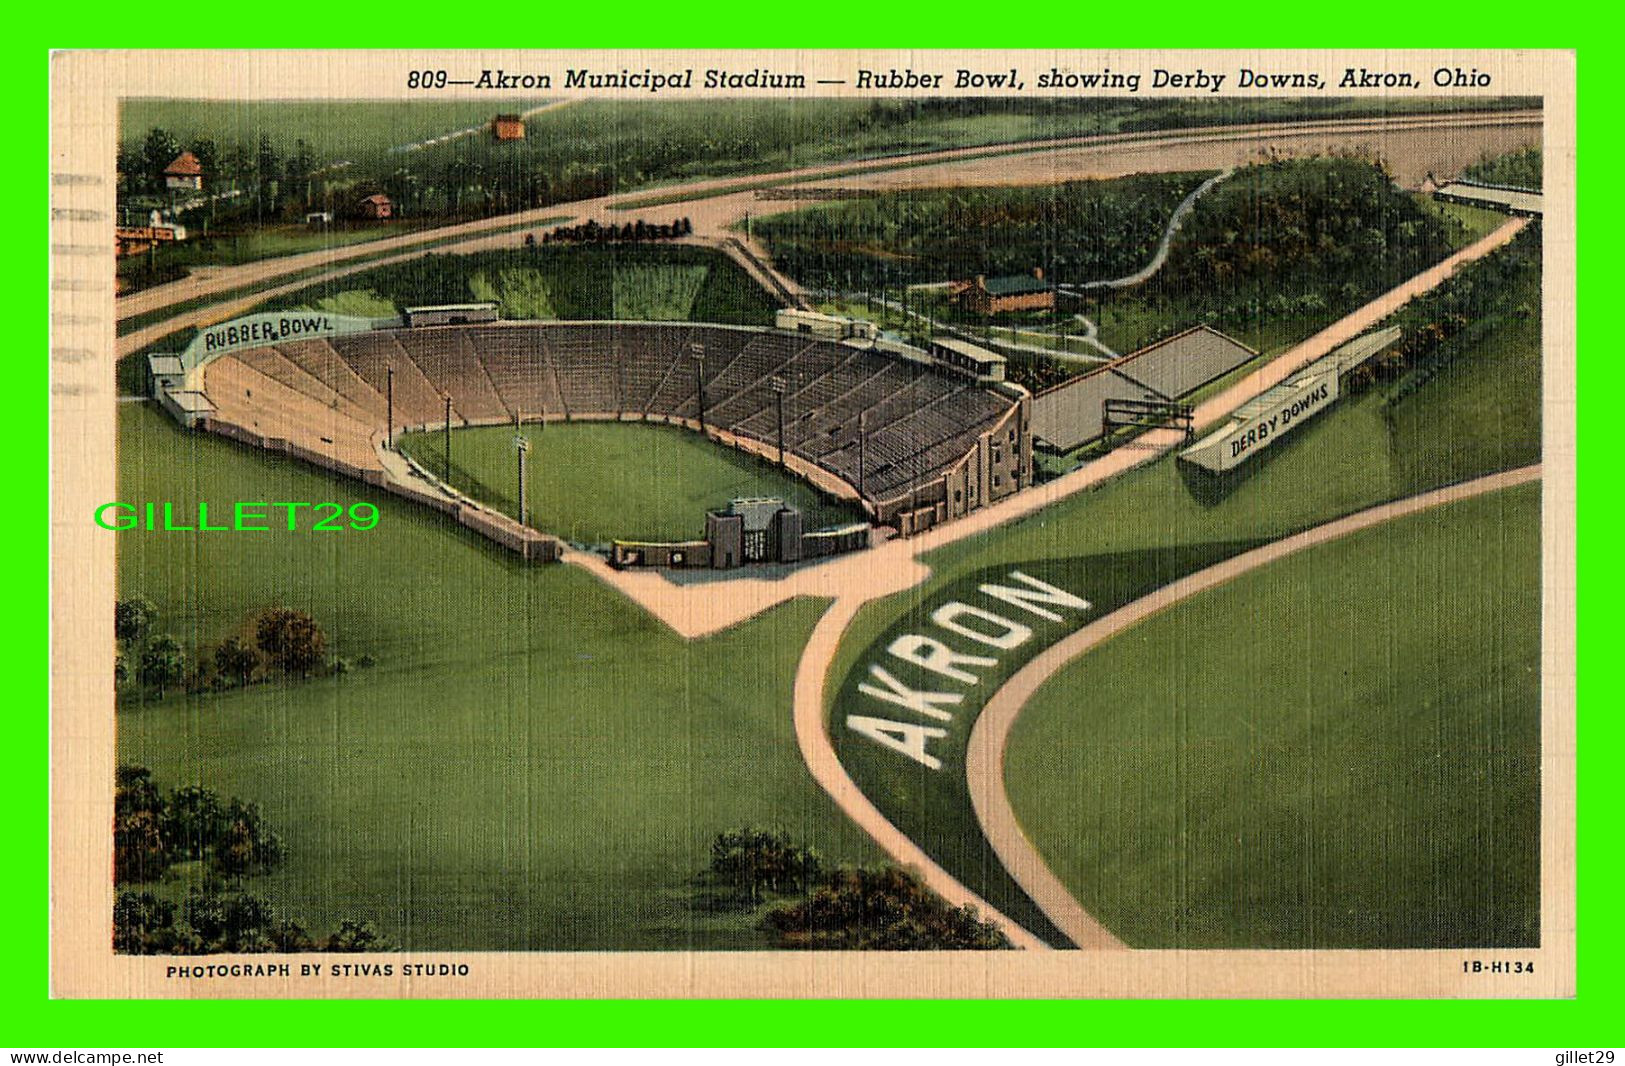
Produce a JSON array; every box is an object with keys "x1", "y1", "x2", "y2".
[{"x1": 400, "y1": 423, "x2": 856, "y2": 544}]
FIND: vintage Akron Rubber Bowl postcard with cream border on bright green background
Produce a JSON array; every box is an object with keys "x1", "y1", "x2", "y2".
[{"x1": 50, "y1": 50, "x2": 1576, "y2": 998}]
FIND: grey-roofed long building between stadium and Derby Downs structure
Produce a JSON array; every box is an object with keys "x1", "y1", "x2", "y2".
[{"x1": 1032, "y1": 325, "x2": 1258, "y2": 452}]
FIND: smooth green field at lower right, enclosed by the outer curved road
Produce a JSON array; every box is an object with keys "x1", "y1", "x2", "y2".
[{"x1": 1004, "y1": 486, "x2": 1541, "y2": 947}]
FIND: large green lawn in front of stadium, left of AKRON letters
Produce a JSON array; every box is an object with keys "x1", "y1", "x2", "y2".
[{"x1": 117, "y1": 405, "x2": 879, "y2": 951}]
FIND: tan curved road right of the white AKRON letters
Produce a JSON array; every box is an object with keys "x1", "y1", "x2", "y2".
[{"x1": 965, "y1": 465, "x2": 1541, "y2": 947}]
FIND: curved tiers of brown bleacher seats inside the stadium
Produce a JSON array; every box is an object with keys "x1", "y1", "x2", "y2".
[{"x1": 205, "y1": 323, "x2": 1016, "y2": 497}]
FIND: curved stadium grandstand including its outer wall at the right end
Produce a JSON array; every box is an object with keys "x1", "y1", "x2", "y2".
[{"x1": 166, "y1": 317, "x2": 1032, "y2": 533}]
